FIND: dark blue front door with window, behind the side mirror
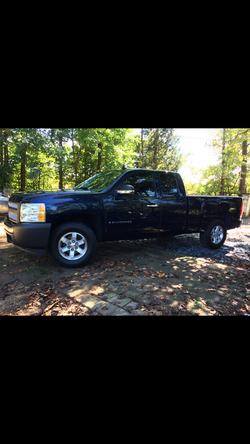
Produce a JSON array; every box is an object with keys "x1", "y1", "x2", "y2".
[{"x1": 104, "y1": 171, "x2": 160, "y2": 240}]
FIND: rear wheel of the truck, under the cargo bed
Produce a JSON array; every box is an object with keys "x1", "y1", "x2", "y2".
[{"x1": 200, "y1": 219, "x2": 227, "y2": 250}]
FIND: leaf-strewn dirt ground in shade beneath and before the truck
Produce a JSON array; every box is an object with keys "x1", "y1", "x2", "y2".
[{"x1": 0, "y1": 219, "x2": 250, "y2": 316}]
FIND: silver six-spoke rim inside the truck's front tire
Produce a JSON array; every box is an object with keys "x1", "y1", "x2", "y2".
[{"x1": 58, "y1": 232, "x2": 88, "y2": 261}]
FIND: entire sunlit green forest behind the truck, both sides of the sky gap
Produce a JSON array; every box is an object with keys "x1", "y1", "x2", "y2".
[{"x1": 0, "y1": 128, "x2": 250, "y2": 196}]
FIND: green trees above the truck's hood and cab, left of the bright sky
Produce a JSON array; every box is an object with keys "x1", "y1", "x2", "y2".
[{"x1": 0, "y1": 128, "x2": 184, "y2": 191}]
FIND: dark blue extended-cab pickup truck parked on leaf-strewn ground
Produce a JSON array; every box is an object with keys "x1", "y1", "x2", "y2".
[{"x1": 4, "y1": 169, "x2": 243, "y2": 268}]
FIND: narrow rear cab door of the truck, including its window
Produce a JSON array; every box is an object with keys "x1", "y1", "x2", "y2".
[{"x1": 157, "y1": 172, "x2": 187, "y2": 235}]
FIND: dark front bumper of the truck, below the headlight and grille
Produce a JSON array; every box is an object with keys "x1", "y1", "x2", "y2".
[{"x1": 4, "y1": 216, "x2": 51, "y2": 256}]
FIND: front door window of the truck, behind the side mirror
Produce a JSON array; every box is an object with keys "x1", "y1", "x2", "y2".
[{"x1": 122, "y1": 173, "x2": 155, "y2": 197}]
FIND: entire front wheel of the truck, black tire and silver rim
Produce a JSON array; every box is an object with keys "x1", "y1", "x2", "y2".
[{"x1": 49, "y1": 222, "x2": 97, "y2": 268}]
